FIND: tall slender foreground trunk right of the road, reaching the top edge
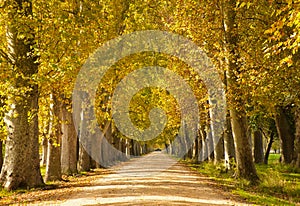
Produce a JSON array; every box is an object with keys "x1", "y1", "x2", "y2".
[{"x1": 223, "y1": 0, "x2": 259, "y2": 183}]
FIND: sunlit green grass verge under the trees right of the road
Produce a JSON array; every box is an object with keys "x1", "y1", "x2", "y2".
[{"x1": 186, "y1": 154, "x2": 300, "y2": 205}]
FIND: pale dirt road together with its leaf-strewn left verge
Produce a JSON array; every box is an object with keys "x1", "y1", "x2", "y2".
[{"x1": 0, "y1": 152, "x2": 248, "y2": 206}]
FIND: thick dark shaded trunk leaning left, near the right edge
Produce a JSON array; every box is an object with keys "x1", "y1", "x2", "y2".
[{"x1": 275, "y1": 107, "x2": 295, "y2": 164}]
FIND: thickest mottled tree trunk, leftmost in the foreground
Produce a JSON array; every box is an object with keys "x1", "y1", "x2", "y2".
[{"x1": 0, "y1": 0, "x2": 43, "y2": 190}]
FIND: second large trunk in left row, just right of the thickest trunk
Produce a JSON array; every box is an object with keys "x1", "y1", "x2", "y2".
[{"x1": 45, "y1": 94, "x2": 61, "y2": 182}]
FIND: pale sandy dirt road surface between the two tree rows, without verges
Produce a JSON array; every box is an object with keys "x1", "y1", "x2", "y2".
[{"x1": 32, "y1": 152, "x2": 246, "y2": 206}]
